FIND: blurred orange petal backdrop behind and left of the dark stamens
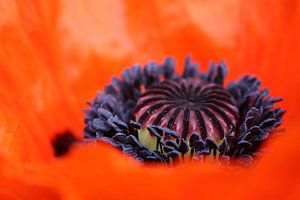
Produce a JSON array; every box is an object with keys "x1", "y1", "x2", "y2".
[{"x1": 0, "y1": 0, "x2": 300, "y2": 169}]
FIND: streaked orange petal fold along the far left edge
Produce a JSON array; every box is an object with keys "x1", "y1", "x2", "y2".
[{"x1": 0, "y1": 2, "x2": 61, "y2": 161}]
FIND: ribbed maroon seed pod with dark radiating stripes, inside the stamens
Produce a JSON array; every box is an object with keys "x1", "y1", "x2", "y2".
[{"x1": 134, "y1": 78, "x2": 238, "y2": 140}]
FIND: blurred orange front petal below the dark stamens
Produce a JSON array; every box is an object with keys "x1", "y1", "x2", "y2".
[{"x1": 14, "y1": 128, "x2": 300, "y2": 199}]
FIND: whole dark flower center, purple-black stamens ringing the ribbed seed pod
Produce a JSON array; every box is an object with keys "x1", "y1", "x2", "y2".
[{"x1": 84, "y1": 57, "x2": 285, "y2": 164}]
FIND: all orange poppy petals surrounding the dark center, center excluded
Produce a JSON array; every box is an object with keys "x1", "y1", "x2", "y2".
[{"x1": 0, "y1": 0, "x2": 300, "y2": 199}]
